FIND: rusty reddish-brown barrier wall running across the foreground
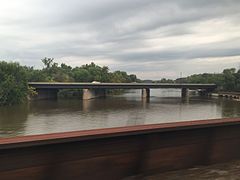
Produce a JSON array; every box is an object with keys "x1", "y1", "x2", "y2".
[{"x1": 0, "y1": 118, "x2": 240, "y2": 180}]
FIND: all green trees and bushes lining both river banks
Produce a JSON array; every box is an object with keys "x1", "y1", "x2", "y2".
[{"x1": 0, "y1": 57, "x2": 240, "y2": 106}]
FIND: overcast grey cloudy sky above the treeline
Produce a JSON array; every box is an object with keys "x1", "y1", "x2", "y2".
[{"x1": 0, "y1": 0, "x2": 240, "y2": 80}]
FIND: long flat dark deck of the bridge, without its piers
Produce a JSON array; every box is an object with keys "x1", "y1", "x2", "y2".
[{"x1": 28, "y1": 82, "x2": 217, "y2": 89}]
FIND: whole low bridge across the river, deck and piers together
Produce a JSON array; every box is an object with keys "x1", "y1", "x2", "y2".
[{"x1": 28, "y1": 82, "x2": 217, "y2": 99}]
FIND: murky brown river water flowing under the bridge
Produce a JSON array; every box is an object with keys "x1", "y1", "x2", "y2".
[{"x1": 0, "y1": 89, "x2": 240, "y2": 137}]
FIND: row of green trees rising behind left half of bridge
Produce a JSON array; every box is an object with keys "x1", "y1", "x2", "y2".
[{"x1": 36, "y1": 58, "x2": 138, "y2": 83}]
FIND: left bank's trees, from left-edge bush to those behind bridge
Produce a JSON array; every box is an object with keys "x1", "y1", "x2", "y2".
[{"x1": 0, "y1": 58, "x2": 140, "y2": 105}]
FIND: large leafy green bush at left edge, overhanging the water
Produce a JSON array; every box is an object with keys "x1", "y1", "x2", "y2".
[{"x1": 0, "y1": 61, "x2": 28, "y2": 105}]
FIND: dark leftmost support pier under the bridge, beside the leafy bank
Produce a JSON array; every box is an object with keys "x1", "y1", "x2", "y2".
[{"x1": 30, "y1": 89, "x2": 58, "y2": 100}]
